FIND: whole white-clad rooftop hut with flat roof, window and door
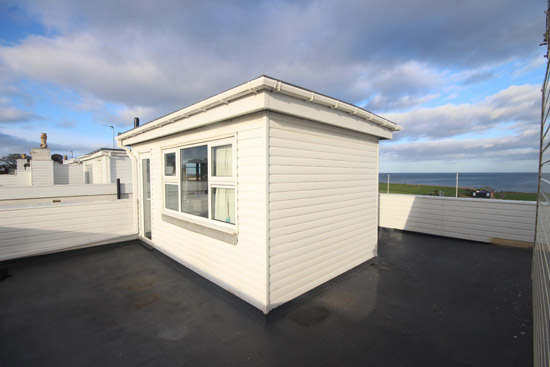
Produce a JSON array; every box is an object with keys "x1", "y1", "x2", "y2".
[{"x1": 117, "y1": 76, "x2": 400, "y2": 313}]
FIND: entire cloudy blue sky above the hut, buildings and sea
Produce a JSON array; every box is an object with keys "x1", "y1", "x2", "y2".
[{"x1": 0, "y1": 0, "x2": 547, "y2": 172}]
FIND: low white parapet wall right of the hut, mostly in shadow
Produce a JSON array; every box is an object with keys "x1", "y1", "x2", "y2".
[{"x1": 379, "y1": 194, "x2": 536, "y2": 247}]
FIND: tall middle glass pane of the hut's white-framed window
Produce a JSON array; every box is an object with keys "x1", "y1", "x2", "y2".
[{"x1": 181, "y1": 145, "x2": 208, "y2": 218}]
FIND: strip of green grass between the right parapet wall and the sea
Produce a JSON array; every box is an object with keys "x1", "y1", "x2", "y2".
[{"x1": 378, "y1": 182, "x2": 537, "y2": 201}]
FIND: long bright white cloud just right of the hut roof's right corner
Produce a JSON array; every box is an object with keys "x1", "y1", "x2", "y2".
[{"x1": 385, "y1": 84, "x2": 540, "y2": 139}]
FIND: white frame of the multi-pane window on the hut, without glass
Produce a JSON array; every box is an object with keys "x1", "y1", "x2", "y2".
[{"x1": 161, "y1": 136, "x2": 238, "y2": 231}]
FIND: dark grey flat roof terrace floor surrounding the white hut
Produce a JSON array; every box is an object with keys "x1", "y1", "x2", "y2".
[{"x1": 0, "y1": 229, "x2": 533, "y2": 367}]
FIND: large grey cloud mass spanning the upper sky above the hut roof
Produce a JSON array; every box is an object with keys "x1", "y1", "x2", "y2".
[{"x1": 0, "y1": 0, "x2": 544, "y2": 112}]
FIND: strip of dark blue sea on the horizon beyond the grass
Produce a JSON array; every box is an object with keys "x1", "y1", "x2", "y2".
[{"x1": 379, "y1": 172, "x2": 538, "y2": 192}]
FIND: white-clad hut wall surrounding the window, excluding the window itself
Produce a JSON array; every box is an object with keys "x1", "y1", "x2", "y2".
[{"x1": 133, "y1": 114, "x2": 267, "y2": 311}]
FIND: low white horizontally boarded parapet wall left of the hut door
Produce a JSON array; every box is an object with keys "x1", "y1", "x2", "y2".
[{"x1": 0, "y1": 200, "x2": 135, "y2": 261}]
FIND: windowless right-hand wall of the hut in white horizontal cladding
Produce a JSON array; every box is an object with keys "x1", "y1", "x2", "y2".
[{"x1": 269, "y1": 113, "x2": 378, "y2": 308}]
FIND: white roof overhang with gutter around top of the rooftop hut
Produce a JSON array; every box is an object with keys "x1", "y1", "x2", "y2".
[{"x1": 117, "y1": 76, "x2": 401, "y2": 145}]
